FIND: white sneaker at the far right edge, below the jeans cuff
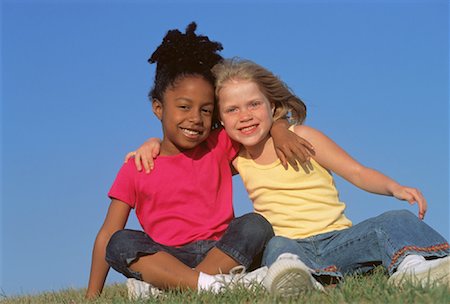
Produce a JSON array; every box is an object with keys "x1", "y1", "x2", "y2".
[{"x1": 388, "y1": 256, "x2": 450, "y2": 287}]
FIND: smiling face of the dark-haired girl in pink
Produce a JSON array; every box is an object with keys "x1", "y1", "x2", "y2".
[{"x1": 153, "y1": 76, "x2": 214, "y2": 155}]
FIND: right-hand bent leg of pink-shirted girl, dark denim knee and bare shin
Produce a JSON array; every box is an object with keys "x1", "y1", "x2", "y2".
[{"x1": 195, "y1": 213, "x2": 274, "y2": 274}]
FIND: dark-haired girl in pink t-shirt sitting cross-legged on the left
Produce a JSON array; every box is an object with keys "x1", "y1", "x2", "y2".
[{"x1": 86, "y1": 23, "x2": 308, "y2": 298}]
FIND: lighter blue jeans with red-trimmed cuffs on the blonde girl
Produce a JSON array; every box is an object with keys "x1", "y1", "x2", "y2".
[{"x1": 263, "y1": 210, "x2": 449, "y2": 279}]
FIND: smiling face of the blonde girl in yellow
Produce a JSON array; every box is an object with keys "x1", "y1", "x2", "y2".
[{"x1": 218, "y1": 79, "x2": 273, "y2": 148}]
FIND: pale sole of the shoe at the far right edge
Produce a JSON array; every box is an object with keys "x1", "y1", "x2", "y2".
[{"x1": 388, "y1": 257, "x2": 450, "y2": 287}]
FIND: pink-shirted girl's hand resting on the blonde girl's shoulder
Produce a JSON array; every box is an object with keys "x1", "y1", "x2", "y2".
[{"x1": 270, "y1": 119, "x2": 314, "y2": 171}]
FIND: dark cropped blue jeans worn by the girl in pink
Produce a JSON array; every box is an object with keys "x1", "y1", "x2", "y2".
[{"x1": 106, "y1": 213, "x2": 274, "y2": 280}]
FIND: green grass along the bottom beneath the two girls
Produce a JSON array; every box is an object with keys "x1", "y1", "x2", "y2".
[{"x1": 0, "y1": 269, "x2": 450, "y2": 304}]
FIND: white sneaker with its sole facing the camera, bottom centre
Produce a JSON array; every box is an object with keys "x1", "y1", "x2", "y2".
[{"x1": 263, "y1": 253, "x2": 324, "y2": 297}]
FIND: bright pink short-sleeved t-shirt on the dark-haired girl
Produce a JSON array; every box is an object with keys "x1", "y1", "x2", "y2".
[{"x1": 108, "y1": 129, "x2": 239, "y2": 246}]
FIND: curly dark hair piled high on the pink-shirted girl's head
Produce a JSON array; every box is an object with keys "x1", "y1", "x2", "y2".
[{"x1": 148, "y1": 22, "x2": 223, "y2": 102}]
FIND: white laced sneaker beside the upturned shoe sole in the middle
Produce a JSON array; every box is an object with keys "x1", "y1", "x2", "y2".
[{"x1": 208, "y1": 266, "x2": 268, "y2": 293}]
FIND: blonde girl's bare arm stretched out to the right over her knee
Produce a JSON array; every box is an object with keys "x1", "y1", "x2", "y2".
[{"x1": 295, "y1": 126, "x2": 427, "y2": 219}]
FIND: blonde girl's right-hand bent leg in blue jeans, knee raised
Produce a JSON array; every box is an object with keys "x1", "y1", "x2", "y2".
[{"x1": 316, "y1": 210, "x2": 449, "y2": 274}]
